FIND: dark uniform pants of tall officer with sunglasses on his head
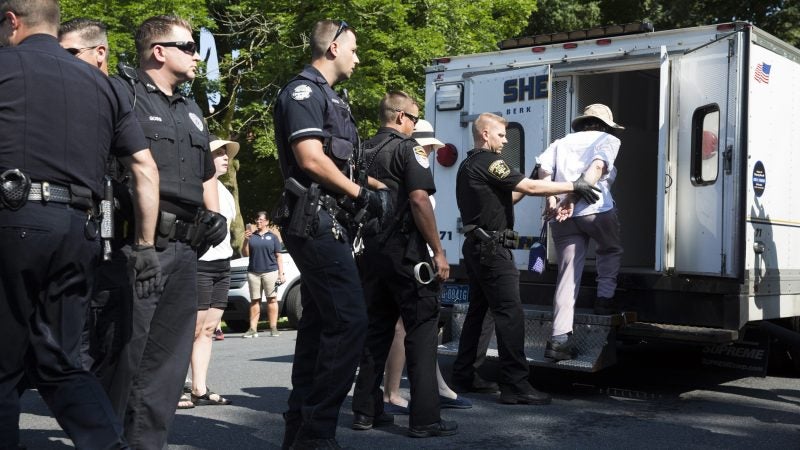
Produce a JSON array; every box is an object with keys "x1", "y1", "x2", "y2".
[{"x1": 285, "y1": 210, "x2": 367, "y2": 439}]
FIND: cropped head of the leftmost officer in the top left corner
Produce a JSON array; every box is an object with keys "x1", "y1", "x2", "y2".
[{"x1": 0, "y1": 0, "x2": 61, "y2": 45}]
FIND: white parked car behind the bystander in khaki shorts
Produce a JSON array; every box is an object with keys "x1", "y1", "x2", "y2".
[{"x1": 222, "y1": 250, "x2": 303, "y2": 333}]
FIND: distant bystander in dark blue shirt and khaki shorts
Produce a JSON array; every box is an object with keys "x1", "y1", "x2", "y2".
[{"x1": 242, "y1": 211, "x2": 286, "y2": 338}]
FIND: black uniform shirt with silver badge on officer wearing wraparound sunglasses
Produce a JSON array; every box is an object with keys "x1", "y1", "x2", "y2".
[{"x1": 113, "y1": 69, "x2": 216, "y2": 216}]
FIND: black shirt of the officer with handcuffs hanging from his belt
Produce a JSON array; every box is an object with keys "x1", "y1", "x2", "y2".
[{"x1": 364, "y1": 127, "x2": 436, "y2": 230}]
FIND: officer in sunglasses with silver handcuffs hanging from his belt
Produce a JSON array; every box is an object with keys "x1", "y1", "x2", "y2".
[{"x1": 352, "y1": 91, "x2": 458, "y2": 437}]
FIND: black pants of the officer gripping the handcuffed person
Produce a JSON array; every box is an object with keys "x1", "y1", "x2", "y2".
[{"x1": 453, "y1": 240, "x2": 529, "y2": 389}]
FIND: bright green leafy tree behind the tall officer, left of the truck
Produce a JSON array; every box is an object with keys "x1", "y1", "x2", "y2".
[{"x1": 207, "y1": 0, "x2": 535, "y2": 250}]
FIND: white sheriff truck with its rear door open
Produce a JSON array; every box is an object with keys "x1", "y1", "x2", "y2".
[{"x1": 425, "y1": 22, "x2": 800, "y2": 371}]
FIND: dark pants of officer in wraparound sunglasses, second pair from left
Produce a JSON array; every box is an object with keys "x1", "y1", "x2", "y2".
[{"x1": 109, "y1": 241, "x2": 197, "y2": 449}]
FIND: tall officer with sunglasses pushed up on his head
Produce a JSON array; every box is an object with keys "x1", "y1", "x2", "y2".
[{"x1": 273, "y1": 20, "x2": 384, "y2": 449}]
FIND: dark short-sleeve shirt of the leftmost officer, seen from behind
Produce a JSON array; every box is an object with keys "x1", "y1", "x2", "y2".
[{"x1": 0, "y1": 34, "x2": 147, "y2": 198}]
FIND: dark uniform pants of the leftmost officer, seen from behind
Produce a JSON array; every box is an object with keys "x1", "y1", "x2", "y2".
[{"x1": 0, "y1": 202, "x2": 124, "y2": 448}]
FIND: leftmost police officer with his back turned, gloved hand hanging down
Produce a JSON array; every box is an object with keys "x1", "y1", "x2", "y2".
[{"x1": 0, "y1": 0, "x2": 161, "y2": 448}]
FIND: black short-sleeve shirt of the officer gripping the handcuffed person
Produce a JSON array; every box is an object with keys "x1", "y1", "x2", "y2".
[{"x1": 456, "y1": 149, "x2": 525, "y2": 231}]
